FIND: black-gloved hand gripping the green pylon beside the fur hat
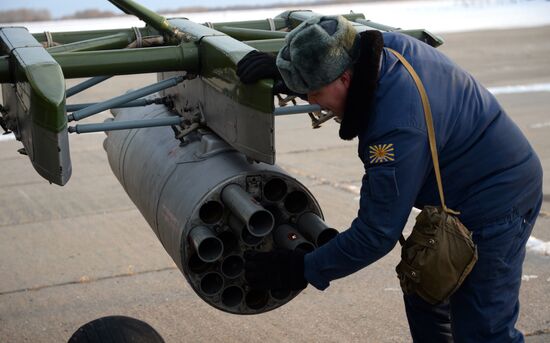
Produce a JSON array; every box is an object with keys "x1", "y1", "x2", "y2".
[{"x1": 237, "y1": 50, "x2": 281, "y2": 84}]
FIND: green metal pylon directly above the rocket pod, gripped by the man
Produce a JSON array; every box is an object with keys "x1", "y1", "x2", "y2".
[{"x1": 159, "y1": 19, "x2": 275, "y2": 164}]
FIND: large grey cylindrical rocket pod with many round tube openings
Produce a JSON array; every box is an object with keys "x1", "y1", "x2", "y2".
[{"x1": 104, "y1": 103, "x2": 328, "y2": 314}]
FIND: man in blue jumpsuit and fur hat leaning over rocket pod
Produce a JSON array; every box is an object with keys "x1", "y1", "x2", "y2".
[{"x1": 238, "y1": 17, "x2": 542, "y2": 342}]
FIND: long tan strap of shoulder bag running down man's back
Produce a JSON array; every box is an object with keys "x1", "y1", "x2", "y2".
[{"x1": 386, "y1": 47, "x2": 460, "y2": 215}]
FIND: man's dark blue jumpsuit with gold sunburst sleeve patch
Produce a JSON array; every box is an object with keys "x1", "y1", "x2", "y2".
[{"x1": 305, "y1": 33, "x2": 542, "y2": 342}]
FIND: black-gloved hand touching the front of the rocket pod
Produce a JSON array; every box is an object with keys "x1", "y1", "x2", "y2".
[{"x1": 244, "y1": 249, "x2": 307, "y2": 291}]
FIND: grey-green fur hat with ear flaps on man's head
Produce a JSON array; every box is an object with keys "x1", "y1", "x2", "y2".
[{"x1": 277, "y1": 16, "x2": 358, "y2": 93}]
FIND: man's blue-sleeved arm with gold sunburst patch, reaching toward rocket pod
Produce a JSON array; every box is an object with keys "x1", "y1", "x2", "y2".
[{"x1": 304, "y1": 127, "x2": 432, "y2": 289}]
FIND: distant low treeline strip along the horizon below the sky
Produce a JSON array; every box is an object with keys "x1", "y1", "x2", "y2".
[{"x1": 0, "y1": 0, "x2": 396, "y2": 23}]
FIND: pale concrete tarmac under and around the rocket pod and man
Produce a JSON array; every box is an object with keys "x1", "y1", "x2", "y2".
[{"x1": 0, "y1": 27, "x2": 550, "y2": 342}]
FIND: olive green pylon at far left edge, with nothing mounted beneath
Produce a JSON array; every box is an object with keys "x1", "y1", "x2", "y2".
[{"x1": 0, "y1": 27, "x2": 71, "y2": 185}]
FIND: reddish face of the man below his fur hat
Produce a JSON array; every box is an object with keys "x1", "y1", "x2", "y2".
[{"x1": 307, "y1": 70, "x2": 351, "y2": 118}]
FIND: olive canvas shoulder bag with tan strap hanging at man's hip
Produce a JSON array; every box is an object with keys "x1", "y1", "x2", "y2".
[{"x1": 387, "y1": 48, "x2": 477, "y2": 304}]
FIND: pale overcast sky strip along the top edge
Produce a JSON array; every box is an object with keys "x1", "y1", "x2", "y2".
[{"x1": 0, "y1": 0, "x2": 302, "y2": 18}]
